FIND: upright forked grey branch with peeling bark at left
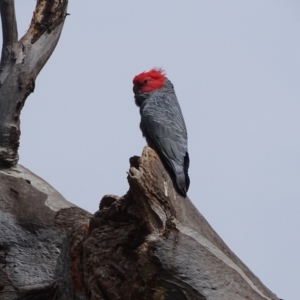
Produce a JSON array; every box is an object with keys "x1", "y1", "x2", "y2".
[{"x1": 0, "y1": 0, "x2": 68, "y2": 167}]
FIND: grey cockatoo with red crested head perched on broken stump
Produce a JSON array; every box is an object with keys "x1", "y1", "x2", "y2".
[{"x1": 133, "y1": 68, "x2": 190, "y2": 197}]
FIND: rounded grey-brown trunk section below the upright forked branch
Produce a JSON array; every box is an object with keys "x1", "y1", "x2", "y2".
[{"x1": 0, "y1": 165, "x2": 90, "y2": 300}]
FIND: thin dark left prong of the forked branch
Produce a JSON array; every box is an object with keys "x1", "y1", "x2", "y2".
[{"x1": 0, "y1": 0, "x2": 18, "y2": 68}]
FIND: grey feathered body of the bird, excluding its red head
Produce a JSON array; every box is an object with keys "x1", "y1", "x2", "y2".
[{"x1": 136, "y1": 80, "x2": 190, "y2": 197}]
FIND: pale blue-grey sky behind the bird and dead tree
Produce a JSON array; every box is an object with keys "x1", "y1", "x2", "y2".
[{"x1": 4, "y1": 0, "x2": 300, "y2": 300}]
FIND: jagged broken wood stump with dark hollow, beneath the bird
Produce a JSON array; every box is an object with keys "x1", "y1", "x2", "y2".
[{"x1": 83, "y1": 147, "x2": 278, "y2": 300}]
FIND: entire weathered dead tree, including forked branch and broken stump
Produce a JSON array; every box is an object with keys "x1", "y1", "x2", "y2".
[{"x1": 0, "y1": 0, "x2": 278, "y2": 300}]
